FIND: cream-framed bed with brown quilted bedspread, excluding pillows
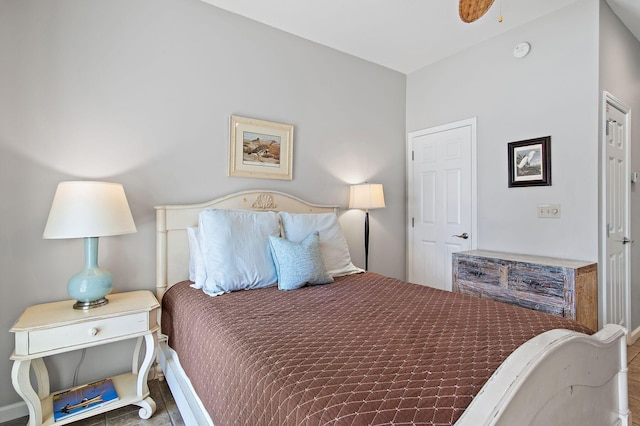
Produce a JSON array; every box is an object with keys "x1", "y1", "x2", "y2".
[{"x1": 156, "y1": 190, "x2": 630, "y2": 426}]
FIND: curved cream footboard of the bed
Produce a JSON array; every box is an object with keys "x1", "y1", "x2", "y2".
[{"x1": 456, "y1": 325, "x2": 630, "y2": 426}]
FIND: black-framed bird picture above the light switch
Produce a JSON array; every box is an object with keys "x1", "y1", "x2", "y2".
[{"x1": 507, "y1": 136, "x2": 551, "y2": 188}]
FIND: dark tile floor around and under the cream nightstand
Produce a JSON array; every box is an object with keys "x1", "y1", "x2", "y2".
[{"x1": 0, "y1": 380, "x2": 184, "y2": 426}]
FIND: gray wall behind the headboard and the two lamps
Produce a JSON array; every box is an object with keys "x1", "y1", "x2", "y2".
[{"x1": 0, "y1": 0, "x2": 406, "y2": 415}]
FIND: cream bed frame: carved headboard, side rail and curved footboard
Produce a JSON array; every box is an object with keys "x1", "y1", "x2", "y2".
[{"x1": 156, "y1": 190, "x2": 631, "y2": 426}]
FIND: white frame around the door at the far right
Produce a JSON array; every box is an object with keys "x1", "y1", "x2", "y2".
[{"x1": 598, "y1": 91, "x2": 632, "y2": 332}]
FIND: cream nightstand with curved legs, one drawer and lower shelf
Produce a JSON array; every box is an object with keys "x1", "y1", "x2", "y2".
[{"x1": 9, "y1": 291, "x2": 160, "y2": 426}]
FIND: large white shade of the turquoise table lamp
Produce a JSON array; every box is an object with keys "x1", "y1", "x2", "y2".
[{"x1": 42, "y1": 181, "x2": 136, "y2": 239}]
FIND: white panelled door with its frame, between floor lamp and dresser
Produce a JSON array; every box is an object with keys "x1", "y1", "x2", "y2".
[{"x1": 407, "y1": 118, "x2": 477, "y2": 290}]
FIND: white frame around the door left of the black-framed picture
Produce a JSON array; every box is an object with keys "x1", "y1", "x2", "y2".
[{"x1": 405, "y1": 117, "x2": 478, "y2": 278}]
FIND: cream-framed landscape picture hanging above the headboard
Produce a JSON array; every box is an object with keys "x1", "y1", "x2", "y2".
[{"x1": 229, "y1": 115, "x2": 293, "y2": 180}]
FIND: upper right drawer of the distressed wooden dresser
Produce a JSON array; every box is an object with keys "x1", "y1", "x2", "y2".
[{"x1": 507, "y1": 265, "x2": 565, "y2": 299}]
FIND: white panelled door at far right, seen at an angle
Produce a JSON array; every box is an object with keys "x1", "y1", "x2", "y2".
[{"x1": 601, "y1": 92, "x2": 632, "y2": 328}]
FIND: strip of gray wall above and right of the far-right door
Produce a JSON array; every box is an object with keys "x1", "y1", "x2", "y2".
[{"x1": 600, "y1": 1, "x2": 640, "y2": 331}]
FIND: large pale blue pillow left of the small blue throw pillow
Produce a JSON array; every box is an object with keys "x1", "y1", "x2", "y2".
[{"x1": 198, "y1": 209, "x2": 280, "y2": 295}]
